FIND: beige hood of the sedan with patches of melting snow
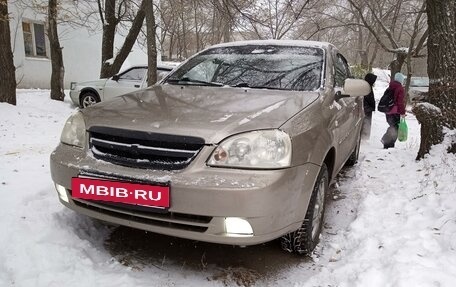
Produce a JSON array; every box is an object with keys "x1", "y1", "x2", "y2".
[{"x1": 82, "y1": 85, "x2": 319, "y2": 143}]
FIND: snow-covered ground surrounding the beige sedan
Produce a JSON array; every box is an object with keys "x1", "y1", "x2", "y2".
[{"x1": 0, "y1": 78, "x2": 456, "y2": 287}]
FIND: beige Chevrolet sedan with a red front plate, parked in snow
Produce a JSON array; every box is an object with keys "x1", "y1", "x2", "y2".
[{"x1": 51, "y1": 40, "x2": 370, "y2": 254}]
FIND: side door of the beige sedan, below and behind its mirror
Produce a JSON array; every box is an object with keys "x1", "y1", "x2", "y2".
[{"x1": 333, "y1": 51, "x2": 361, "y2": 166}]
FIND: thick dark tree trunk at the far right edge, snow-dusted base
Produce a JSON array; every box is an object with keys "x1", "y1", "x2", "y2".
[{"x1": 413, "y1": 0, "x2": 456, "y2": 159}]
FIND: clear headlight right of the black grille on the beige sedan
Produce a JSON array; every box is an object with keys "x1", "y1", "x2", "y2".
[{"x1": 207, "y1": 130, "x2": 291, "y2": 169}]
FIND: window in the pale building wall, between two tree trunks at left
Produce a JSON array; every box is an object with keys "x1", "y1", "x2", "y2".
[{"x1": 22, "y1": 22, "x2": 47, "y2": 57}]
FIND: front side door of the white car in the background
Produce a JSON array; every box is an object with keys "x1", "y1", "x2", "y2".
[{"x1": 103, "y1": 67, "x2": 147, "y2": 100}]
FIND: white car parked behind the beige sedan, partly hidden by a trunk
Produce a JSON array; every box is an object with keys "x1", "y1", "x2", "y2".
[{"x1": 70, "y1": 64, "x2": 175, "y2": 108}]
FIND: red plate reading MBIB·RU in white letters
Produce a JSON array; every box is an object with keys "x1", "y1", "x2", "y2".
[{"x1": 71, "y1": 177, "x2": 170, "y2": 208}]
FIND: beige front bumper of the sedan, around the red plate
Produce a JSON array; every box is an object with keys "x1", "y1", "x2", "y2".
[{"x1": 51, "y1": 144, "x2": 319, "y2": 245}]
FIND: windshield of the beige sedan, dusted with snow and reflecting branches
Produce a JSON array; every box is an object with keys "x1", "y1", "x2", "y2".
[{"x1": 166, "y1": 45, "x2": 324, "y2": 91}]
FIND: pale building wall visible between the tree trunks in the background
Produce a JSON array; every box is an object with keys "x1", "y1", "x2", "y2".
[{"x1": 8, "y1": 4, "x2": 147, "y2": 89}]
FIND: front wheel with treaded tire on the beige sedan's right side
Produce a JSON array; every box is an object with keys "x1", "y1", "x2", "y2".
[{"x1": 281, "y1": 164, "x2": 329, "y2": 255}]
